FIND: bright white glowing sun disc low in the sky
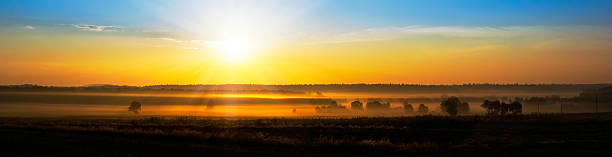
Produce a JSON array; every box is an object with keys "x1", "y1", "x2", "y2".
[{"x1": 209, "y1": 38, "x2": 253, "y2": 62}]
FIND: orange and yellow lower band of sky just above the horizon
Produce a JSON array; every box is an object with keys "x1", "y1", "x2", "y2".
[{"x1": 0, "y1": 25, "x2": 612, "y2": 85}]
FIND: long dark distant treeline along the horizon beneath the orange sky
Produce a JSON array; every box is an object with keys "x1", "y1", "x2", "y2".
[{"x1": 0, "y1": 84, "x2": 610, "y2": 94}]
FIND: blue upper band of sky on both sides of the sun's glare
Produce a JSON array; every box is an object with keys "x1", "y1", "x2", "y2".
[{"x1": 0, "y1": 0, "x2": 612, "y2": 27}]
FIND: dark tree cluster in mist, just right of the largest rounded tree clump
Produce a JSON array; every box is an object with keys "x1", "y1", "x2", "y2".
[{"x1": 481, "y1": 100, "x2": 523, "y2": 115}]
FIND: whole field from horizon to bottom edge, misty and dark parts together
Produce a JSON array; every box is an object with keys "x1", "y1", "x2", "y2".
[{"x1": 0, "y1": 85, "x2": 612, "y2": 156}]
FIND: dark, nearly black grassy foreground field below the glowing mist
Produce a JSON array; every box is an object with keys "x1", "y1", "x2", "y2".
[{"x1": 0, "y1": 113, "x2": 612, "y2": 156}]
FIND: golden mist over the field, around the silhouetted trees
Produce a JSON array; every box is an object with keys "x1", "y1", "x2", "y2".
[{"x1": 0, "y1": 84, "x2": 610, "y2": 117}]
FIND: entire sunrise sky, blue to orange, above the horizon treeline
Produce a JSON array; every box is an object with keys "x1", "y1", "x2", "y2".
[{"x1": 0, "y1": 0, "x2": 612, "y2": 86}]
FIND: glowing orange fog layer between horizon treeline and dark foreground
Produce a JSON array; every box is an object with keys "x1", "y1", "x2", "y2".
[{"x1": 0, "y1": 86, "x2": 609, "y2": 117}]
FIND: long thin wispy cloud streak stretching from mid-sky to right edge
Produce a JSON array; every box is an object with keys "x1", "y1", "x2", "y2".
[{"x1": 315, "y1": 26, "x2": 611, "y2": 44}]
